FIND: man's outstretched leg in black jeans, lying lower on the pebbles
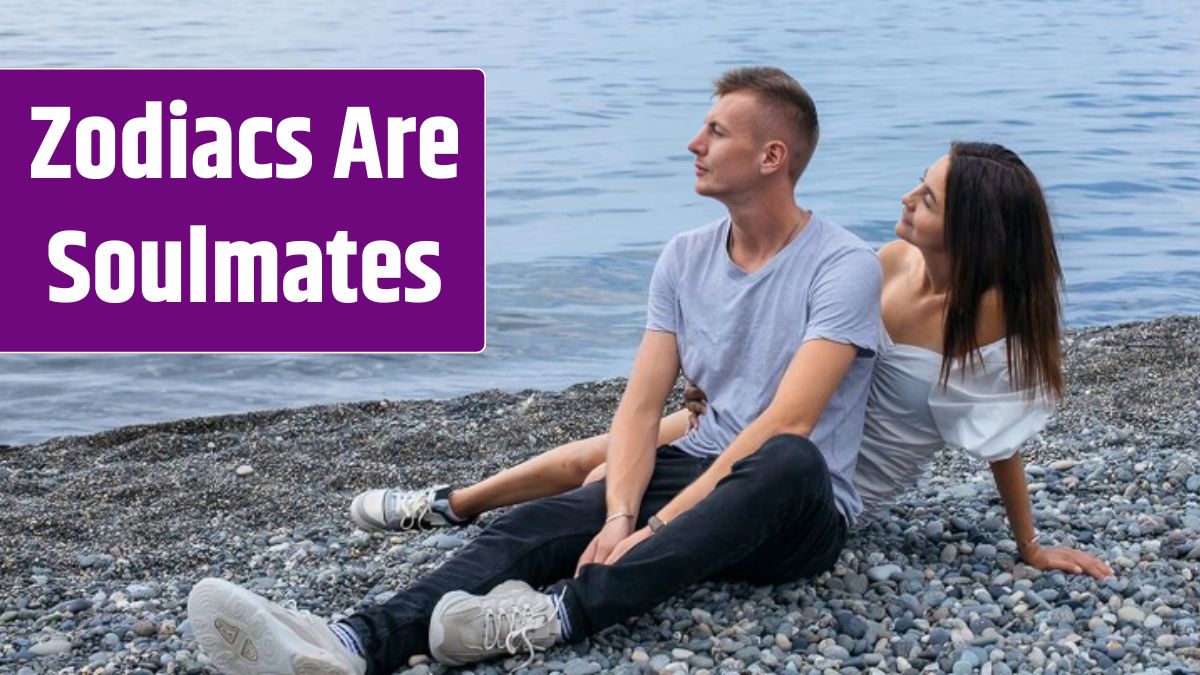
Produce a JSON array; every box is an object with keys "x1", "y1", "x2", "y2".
[{"x1": 346, "y1": 448, "x2": 708, "y2": 673}]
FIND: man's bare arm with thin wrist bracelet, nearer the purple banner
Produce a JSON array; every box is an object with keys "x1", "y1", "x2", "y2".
[{"x1": 578, "y1": 330, "x2": 679, "y2": 567}]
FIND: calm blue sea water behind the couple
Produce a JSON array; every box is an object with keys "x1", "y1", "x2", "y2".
[{"x1": 0, "y1": 0, "x2": 1200, "y2": 443}]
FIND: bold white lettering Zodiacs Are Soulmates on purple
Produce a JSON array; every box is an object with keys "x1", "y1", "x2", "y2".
[{"x1": 30, "y1": 100, "x2": 458, "y2": 303}]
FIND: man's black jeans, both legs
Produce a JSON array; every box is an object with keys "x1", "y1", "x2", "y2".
[{"x1": 346, "y1": 435, "x2": 846, "y2": 674}]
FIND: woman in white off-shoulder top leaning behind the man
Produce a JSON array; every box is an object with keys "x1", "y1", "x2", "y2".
[{"x1": 350, "y1": 143, "x2": 1112, "y2": 578}]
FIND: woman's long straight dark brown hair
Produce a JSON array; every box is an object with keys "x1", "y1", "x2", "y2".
[{"x1": 941, "y1": 143, "x2": 1064, "y2": 399}]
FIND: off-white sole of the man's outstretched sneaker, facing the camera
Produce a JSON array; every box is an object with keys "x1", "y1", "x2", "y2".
[{"x1": 187, "y1": 579, "x2": 348, "y2": 675}]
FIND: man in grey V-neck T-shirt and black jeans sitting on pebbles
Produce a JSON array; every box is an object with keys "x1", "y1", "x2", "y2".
[{"x1": 188, "y1": 67, "x2": 881, "y2": 674}]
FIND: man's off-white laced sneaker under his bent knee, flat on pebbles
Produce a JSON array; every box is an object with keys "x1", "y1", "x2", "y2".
[{"x1": 430, "y1": 581, "x2": 562, "y2": 665}]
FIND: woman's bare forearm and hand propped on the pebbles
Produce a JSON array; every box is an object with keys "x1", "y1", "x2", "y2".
[{"x1": 991, "y1": 453, "x2": 1112, "y2": 579}]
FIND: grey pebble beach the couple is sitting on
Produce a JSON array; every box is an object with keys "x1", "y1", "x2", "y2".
[{"x1": 0, "y1": 317, "x2": 1200, "y2": 675}]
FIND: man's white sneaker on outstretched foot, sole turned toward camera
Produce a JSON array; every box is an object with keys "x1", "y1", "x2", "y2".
[{"x1": 187, "y1": 571, "x2": 367, "y2": 675}]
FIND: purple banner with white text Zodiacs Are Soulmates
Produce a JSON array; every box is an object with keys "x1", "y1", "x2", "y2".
[{"x1": 0, "y1": 70, "x2": 485, "y2": 352}]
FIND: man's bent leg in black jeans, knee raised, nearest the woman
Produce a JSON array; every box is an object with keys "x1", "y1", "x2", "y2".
[{"x1": 564, "y1": 435, "x2": 846, "y2": 639}]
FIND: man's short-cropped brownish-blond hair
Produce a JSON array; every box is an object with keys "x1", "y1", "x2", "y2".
[{"x1": 713, "y1": 66, "x2": 821, "y2": 183}]
